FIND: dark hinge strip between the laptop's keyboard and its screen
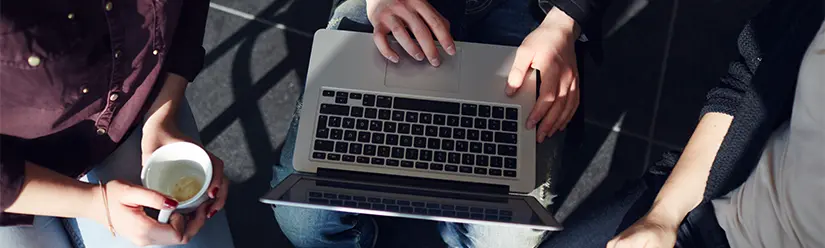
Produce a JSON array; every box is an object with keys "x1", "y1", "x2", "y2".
[{"x1": 317, "y1": 168, "x2": 510, "y2": 195}]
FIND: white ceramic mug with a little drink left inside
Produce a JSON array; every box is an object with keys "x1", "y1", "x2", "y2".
[{"x1": 140, "y1": 142, "x2": 212, "y2": 223}]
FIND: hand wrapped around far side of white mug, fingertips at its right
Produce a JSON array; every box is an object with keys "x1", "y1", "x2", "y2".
[{"x1": 141, "y1": 119, "x2": 229, "y2": 235}]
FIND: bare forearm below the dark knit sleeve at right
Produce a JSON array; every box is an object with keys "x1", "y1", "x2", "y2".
[{"x1": 649, "y1": 113, "x2": 733, "y2": 225}]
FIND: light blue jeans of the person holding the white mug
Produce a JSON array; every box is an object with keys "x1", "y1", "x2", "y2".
[{"x1": 0, "y1": 101, "x2": 234, "y2": 248}]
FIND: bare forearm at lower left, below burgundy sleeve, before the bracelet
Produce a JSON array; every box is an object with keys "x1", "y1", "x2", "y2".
[{"x1": 5, "y1": 163, "x2": 101, "y2": 218}]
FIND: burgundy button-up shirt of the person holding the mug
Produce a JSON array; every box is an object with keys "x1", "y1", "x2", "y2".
[{"x1": 0, "y1": 0, "x2": 209, "y2": 225}]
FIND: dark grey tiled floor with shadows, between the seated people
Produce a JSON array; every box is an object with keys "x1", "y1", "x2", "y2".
[{"x1": 187, "y1": 0, "x2": 752, "y2": 247}]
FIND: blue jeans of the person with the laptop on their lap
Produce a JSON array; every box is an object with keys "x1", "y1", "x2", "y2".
[{"x1": 272, "y1": 0, "x2": 563, "y2": 247}]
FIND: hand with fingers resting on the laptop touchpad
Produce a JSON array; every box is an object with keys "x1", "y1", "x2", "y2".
[{"x1": 367, "y1": 0, "x2": 455, "y2": 66}]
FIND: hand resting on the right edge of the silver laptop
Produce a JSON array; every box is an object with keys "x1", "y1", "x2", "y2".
[{"x1": 505, "y1": 8, "x2": 579, "y2": 142}]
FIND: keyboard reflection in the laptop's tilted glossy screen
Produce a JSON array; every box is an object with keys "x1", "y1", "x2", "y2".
[{"x1": 308, "y1": 191, "x2": 513, "y2": 221}]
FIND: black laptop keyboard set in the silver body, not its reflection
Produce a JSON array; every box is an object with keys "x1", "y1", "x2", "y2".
[{"x1": 311, "y1": 88, "x2": 519, "y2": 178}]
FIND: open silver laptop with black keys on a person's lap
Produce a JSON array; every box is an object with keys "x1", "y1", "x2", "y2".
[{"x1": 260, "y1": 29, "x2": 562, "y2": 231}]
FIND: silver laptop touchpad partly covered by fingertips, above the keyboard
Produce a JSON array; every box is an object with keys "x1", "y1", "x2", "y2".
[{"x1": 384, "y1": 42, "x2": 461, "y2": 93}]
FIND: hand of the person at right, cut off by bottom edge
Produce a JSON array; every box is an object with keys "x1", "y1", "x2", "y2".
[{"x1": 607, "y1": 215, "x2": 678, "y2": 248}]
